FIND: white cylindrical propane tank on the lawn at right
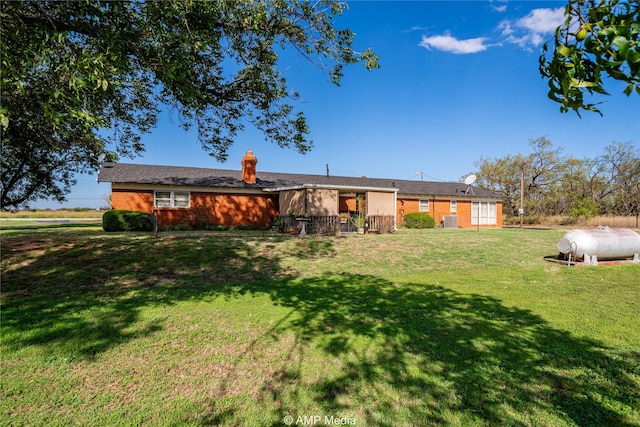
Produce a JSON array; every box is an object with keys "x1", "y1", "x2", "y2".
[{"x1": 558, "y1": 227, "x2": 640, "y2": 264}]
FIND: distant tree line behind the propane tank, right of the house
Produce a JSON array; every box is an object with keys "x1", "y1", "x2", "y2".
[{"x1": 475, "y1": 137, "x2": 640, "y2": 218}]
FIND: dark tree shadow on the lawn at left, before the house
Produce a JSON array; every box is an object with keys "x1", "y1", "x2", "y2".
[{"x1": 2, "y1": 233, "x2": 302, "y2": 361}]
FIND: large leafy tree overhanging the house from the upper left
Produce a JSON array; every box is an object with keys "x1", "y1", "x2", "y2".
[{"x1": 0, "y1": 0, "x2": 378, "y2": 208}]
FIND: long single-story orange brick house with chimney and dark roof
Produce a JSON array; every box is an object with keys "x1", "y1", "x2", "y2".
[{"x1": 98, "y1": 151, "x2": 504, "y2": 231}]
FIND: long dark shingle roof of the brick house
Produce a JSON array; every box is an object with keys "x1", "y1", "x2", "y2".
[{"x1": 98, "y1": 163, "x2": 504, "y2": 198}]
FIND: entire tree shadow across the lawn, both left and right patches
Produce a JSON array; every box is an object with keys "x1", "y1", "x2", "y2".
[{"x1": 2, "y1": 233, "x2": 640, "y2": 426}]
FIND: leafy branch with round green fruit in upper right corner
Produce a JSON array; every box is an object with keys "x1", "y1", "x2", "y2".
[{"x1": 540, "y1": 0, "x2": 640, "y2": 115}]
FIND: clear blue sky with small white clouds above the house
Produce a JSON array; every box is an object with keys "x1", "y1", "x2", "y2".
[{"x1": 42, "y1": 1, "x2": 640, "y2": 208}]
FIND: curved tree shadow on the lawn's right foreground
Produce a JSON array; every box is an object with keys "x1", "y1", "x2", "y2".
[{"x1": 234, "y1": 274, "x2": 640, "y2": 426}]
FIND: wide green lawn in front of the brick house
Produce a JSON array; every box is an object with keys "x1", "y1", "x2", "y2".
[{"x1": 0, "y1": 227, "x2": 640, "y2": 426}]
